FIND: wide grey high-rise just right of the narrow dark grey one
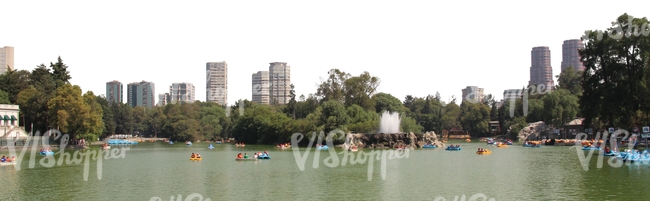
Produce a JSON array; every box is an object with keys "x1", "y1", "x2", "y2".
[{"x1": 127, "y1": 80, "x2": 156, "y2": 108}]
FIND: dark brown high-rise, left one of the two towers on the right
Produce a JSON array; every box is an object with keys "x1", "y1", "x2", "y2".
[{"x1": 528, "y1": 46, "x2": 555, "y2": 90}]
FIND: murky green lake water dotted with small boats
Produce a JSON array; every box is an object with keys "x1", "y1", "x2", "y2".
[{"x1": 0, "y1": 141, "x2": 650, "y2": 201}]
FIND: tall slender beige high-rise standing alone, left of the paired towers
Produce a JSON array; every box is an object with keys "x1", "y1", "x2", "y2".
[{"x1": 205, "y1": 61, "x2": 228, "y2": 105}]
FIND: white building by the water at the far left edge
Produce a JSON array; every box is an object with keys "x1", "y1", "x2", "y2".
[{"x1": 0, "y1": 104, "x2": 29, "y2": 139}]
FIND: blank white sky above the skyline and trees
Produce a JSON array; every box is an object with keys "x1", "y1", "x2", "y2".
[{"x1": 0, "y1": 0, "x2": 650, "y2": 104}]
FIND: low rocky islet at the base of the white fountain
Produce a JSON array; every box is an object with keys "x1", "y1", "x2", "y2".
[{"x1": 347, "y1": 132, "x2": 446, "y2": 148}]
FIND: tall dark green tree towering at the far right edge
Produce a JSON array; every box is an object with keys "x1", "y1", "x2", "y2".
[{"x1": 579, "y1": 13, "x2": 650, "y2": 127}]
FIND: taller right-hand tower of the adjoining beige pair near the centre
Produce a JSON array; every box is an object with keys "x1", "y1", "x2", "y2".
[{"x1": 269, "y1": 62, "x2": 291, "y2": 104}]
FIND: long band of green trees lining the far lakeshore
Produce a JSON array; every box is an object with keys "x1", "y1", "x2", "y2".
[{"x1": 0, "y1": 14, "x2": 650, "y2": 144}]
